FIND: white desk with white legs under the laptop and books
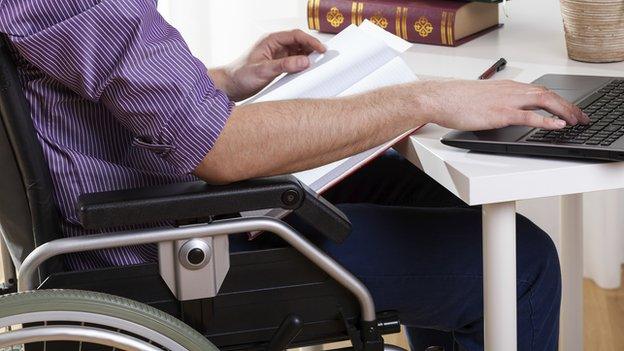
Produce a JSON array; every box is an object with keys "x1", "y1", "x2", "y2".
[{"x1": 397, "y1": 0, "x2": 624, "y2": 351}]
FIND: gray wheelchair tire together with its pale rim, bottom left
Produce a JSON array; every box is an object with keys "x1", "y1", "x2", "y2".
[{"x1": 0, "y1": 290, "x2": 218, "y2": 351}]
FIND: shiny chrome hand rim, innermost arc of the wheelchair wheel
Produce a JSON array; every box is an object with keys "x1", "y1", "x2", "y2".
[{"x1": 0, "y1": 326, "x2": 162, "y2": 351}]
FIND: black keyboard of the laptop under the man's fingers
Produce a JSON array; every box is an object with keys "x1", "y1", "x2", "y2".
[{"x1": 526, "y1": 79, "x2": 624, "y2": 146}]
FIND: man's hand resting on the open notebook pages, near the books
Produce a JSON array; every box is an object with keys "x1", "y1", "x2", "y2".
[{"x1": 210, "y1": 29, "x2": 325, "y2": 101}]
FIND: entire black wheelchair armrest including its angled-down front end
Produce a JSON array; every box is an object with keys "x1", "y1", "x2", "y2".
[{"x1": 78, "y1": 176, "x2": 351, "y2": 243}]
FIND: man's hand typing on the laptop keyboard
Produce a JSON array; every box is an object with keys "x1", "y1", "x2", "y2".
[{"x1": 417, "y1": 80, "x2": 589, "y2": 131}]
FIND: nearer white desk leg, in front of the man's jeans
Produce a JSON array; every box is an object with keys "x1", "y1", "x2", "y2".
[{"x1": 483, "y1": 202, "x2": 518, "y2": 351}]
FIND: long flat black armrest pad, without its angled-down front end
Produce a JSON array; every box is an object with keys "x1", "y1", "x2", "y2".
[{"x1": 78, "y1": 177, "x2": 304, "y2": 229}]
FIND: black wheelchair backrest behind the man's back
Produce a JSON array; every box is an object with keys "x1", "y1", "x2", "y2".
[{"x1": 0, "y1": 34, "x2": 62, "y2": 277}]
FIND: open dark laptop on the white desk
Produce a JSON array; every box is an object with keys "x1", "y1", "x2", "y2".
[{"x1": 442, "y1": 74, "x2": 624, "y2": 161}]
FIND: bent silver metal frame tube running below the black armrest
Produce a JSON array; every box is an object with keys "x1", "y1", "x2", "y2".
[{"x1": 17, "y1": 217, "x2": 377, "y2": 322}]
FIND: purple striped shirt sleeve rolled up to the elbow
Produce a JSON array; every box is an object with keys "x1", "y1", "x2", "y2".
[{"x1": 0, "y1": 0, "x2": 233, "y2": 173}]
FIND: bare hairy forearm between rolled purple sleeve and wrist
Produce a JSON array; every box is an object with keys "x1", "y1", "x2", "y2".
[{"x1": 196, "y1": 86, "x2": 427, "y2": 183}]
